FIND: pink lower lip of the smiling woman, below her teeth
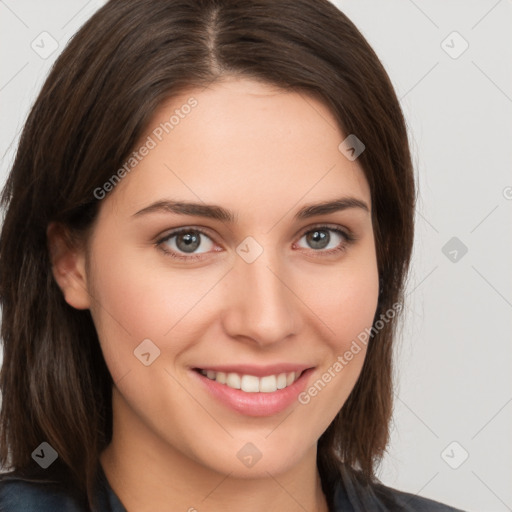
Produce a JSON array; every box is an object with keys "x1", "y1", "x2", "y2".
[{"x1": 192, "y1": 368, "x2": 313, "y2": 416}]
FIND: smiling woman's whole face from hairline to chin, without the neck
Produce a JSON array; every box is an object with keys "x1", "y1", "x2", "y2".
[{"x1": 63, "y1": 79, "x2": 378, "y2": 477}]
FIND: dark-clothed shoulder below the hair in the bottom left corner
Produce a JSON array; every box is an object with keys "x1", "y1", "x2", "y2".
[{"x1": 0, "y1": 472, "x2": 85, "y2": 512}]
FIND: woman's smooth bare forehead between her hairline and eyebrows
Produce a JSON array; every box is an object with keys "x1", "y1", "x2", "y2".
[{"x1": 106, "y1": 79, "x2": 370, "y2": 222}]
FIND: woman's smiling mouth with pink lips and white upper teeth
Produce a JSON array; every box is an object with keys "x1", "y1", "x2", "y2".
[{"x1": 191, "y1": 365, "x2": 314, "y2": 416}]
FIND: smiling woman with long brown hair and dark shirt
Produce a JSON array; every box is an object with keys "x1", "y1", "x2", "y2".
[{"x1": 0, "y1": 0, "x2": 464, "y2": 512}]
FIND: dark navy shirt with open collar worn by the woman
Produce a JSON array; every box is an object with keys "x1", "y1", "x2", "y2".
[{"x1": 0, "y1": 466, "x2": 462, "y2": 512}]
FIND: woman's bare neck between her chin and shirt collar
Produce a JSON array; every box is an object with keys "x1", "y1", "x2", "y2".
[{"x1": 100, "y1": 390, "x2": 328, "y2": 512}]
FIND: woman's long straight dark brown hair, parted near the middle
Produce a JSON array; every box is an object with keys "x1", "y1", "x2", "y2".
[{"x1": 0, "y1": 0, "x2": 415, "y2": 503}]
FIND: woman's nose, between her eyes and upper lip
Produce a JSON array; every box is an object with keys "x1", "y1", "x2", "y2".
[{"x1": 222, "y1": 245, "x2": 301, "y2": 346}]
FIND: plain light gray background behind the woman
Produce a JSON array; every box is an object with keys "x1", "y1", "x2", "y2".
[{"x1": 0, "y1": 0, "x2": 512, "y2": 511}]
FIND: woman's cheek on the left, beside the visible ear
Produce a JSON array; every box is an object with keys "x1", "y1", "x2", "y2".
[{"x1": 86, "y1": 237, "x2": 219, "y2": 382}]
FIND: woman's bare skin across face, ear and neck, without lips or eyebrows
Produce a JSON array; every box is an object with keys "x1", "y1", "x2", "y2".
[{"x1": 48, "y1": 78, "x2": 378, "y2": 512}]
